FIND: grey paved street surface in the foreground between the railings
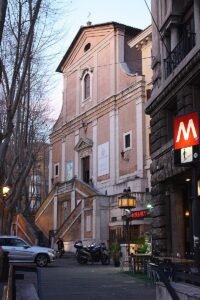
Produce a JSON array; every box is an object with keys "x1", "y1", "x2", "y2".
[{"x1": 41, "y1": 257, "x2": 156, "y2": 300}]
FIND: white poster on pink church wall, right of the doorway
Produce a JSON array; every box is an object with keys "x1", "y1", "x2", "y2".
[{"x1": 98, "y1": 142, "x2": 109, "y2": 176}]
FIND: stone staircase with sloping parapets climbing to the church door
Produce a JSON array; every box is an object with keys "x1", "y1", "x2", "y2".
[{"x1": 15, "y1": 178, "x2": 101, "y2": 246}]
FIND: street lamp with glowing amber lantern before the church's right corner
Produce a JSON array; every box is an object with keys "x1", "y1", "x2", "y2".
[{"x1": 118, "y1": 188, "x2": 136, "y2": 257}]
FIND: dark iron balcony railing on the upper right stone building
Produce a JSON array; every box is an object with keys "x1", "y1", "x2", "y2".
[{"x1": 164, "y1": 32, "x2": 195, "y2": 78}]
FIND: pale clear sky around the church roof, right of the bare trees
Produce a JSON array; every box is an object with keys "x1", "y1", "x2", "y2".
[{"x1": 50, "y1": 0, "x2": 151, "y2": 118}]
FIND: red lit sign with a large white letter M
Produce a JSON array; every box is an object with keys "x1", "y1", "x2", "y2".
[{"x1": 174, "y1": 112, "x2": 199, "y2": 150}]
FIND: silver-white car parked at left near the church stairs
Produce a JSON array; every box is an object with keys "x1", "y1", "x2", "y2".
[{"x1": 0, "y1": 236, "x2": 56, "y2": 267}]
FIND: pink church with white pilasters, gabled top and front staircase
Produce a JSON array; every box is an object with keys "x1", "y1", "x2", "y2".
[{"x1": 36, "y1": 22, "x2": 151, "y2": 251}]
